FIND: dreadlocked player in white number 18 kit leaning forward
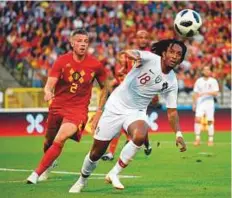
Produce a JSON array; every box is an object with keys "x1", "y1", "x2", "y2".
[{"x1": 69, "y1": 39, "x2": 187, "y2": 193}]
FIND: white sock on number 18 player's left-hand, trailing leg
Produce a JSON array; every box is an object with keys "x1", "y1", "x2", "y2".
[{"x1": 79, "y1": 153, "x2": 98, "y2": 183}]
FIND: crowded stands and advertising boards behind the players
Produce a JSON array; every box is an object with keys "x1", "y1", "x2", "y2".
[{"x1": 0, "y1": 0, "x2": 231, "y2": 197}]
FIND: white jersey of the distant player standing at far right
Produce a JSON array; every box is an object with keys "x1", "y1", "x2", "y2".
[{"x1": 193, "y1": 77, "x2": 219, "y2": 106}]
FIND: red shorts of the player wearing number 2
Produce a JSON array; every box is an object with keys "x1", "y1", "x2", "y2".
[{"x1": 45, "y1": 110, "x2": 88, "y2": 142}]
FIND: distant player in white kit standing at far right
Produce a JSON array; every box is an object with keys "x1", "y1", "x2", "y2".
[{"x1": 193, "y1": 66, "x2": 219, "y2": 146}]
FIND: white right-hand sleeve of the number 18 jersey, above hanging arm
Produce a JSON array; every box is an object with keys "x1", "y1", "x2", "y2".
[{"x1": 161, "y1": 88, "x2": 178, "y2": 108}]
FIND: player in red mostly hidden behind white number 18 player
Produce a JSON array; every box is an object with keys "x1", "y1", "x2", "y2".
[{"x1": 102, "y1": 30, "x2": 152, "y2": 160}]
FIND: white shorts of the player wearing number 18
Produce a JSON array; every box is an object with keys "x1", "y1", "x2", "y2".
[{"x1": 94, "y1": 110, "x2": 148, "y2": 141}]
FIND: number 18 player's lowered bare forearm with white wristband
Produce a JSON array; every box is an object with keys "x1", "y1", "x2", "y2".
[{"x1": 167, "y1": 108, "x2": 187, "y2": 152}]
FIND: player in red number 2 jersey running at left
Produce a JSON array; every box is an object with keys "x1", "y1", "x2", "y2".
[{"x1": 27, "y1": 29, "x2": 108, "y2": 184}]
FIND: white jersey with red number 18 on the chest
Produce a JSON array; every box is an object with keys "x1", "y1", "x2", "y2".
[{"x1": 105, "y1": 50, "x2": 178, "y2": 114}]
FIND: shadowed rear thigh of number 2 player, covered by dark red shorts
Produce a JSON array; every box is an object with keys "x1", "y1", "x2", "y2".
[{"x1": 45, "y1": 112, "x2": 63, "y2": 142}]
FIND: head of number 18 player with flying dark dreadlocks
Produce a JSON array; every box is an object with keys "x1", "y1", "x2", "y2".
[{"x1": 151, "y1": 39, "x2": 187, "y2": 68}]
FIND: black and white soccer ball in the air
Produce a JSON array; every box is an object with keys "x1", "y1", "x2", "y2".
[{"x1": 174, "y1": 9, "x2": 202, "y2": 37}]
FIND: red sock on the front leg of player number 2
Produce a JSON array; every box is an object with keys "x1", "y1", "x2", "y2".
[{"x1": 35, "y1": 142, "x2": 63, "y2": 175}]
